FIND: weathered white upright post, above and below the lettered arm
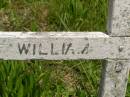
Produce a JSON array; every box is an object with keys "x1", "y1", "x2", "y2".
[{"x1": 99, "y1": 0, "x2": 130, "y2": 97}]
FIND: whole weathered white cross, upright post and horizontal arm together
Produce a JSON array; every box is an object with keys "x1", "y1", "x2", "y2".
[{"x1": 0, "y1": 0, "x2": 130, "y2": 97}]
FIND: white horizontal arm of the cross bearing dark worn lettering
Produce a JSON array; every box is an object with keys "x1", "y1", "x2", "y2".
[{"x1": 0, "y1": 32, "x2": 130, "y2": 60}]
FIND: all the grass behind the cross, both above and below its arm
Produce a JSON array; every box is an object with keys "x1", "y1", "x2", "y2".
[{"x1": 0, "y1": 0, "x2": 130, "y2": 97}]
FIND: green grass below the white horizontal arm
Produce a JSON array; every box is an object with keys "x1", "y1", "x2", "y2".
[{"x1": 0, "y1": 60, "x2": 101, "y2": 97}]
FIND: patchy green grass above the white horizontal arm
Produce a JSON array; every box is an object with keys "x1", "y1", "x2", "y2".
[{"x1": 0, "y1": 0, "x2": 108, "y2": 31}]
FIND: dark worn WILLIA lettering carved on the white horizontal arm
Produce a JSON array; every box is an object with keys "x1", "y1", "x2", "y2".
[{"x1": 17, "y1": 42, "x2": 89, "y2": 56}]
